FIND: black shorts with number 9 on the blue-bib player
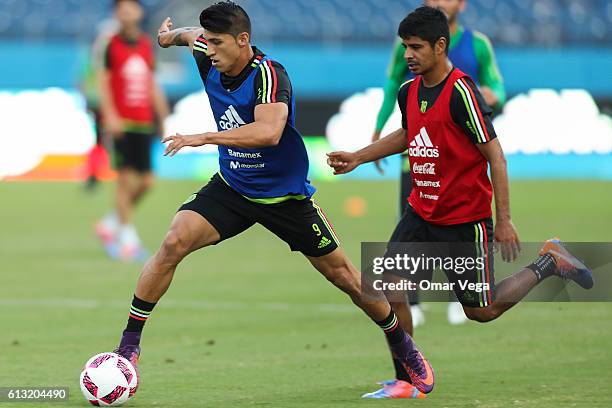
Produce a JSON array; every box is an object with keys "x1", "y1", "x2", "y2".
[{"x1": 179, "y1": 174, "x2": 338, "y2": 257}]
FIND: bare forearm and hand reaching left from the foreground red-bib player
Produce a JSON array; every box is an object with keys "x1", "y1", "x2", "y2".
[{"x1": 327, "y1": 129, "x2": 406, "y2": 174}]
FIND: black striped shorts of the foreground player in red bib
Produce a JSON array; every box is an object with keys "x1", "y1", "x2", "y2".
[{"x1": 386, "y1": 205, "x2": 495, "y2": 307}]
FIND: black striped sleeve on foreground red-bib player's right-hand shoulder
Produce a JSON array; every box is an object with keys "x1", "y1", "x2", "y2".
[{"x1": 451, "y1": 77, "x2": 497, "y2": 144}]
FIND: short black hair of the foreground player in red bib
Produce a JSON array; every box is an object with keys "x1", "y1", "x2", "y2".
[{"x1": 397, "y1": 6, "x2": 450, "y2": 54}]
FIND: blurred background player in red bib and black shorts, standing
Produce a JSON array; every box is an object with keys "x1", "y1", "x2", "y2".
[{"x1": 96, "y1": 0, "x2": 169, "y2": 260}]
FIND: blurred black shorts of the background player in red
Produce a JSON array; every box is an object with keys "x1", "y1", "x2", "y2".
[{"x1": 114, "y1": 132, "x2": 153, "y2": 173}]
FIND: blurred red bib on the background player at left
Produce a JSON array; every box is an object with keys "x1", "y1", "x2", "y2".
[{"x1": 106, "y1": 34, "x2": 154, "y2": 124}]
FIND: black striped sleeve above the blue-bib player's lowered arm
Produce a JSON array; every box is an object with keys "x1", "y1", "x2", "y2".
[{"x1": 253, "y1": 60, "x2": 291, "y2": 106}]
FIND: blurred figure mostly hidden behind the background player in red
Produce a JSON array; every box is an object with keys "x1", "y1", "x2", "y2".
[{"x1": 79, "y1": 18, "x2": 119, "y2": 190}]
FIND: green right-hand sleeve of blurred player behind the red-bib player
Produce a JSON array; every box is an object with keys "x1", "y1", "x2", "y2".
[{"x1": 474, "y1": 31, "x2": 506, "y2": 108}]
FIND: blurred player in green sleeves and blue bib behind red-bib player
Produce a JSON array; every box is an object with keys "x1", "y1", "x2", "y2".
[{"x1": 372, "y1": 0, "x2": 506, "y2": 327}]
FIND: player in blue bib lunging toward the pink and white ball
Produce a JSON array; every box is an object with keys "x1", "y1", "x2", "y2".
[{"x1": 110, "y1": 1, "x2": 434, "y2": 398}]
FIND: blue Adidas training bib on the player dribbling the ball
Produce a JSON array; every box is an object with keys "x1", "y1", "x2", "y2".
[{"x1": 205, "y1": 56, "x2": 315, "y2": 202}]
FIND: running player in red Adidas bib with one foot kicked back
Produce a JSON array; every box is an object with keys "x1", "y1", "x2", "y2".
[{"x1": 328, "y1": 6, "x2": 593, "y2": 398}]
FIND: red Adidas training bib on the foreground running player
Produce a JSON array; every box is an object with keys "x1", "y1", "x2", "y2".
[{"x1": 406, "y1": 69, "x2": 493, "y2": 225}]
